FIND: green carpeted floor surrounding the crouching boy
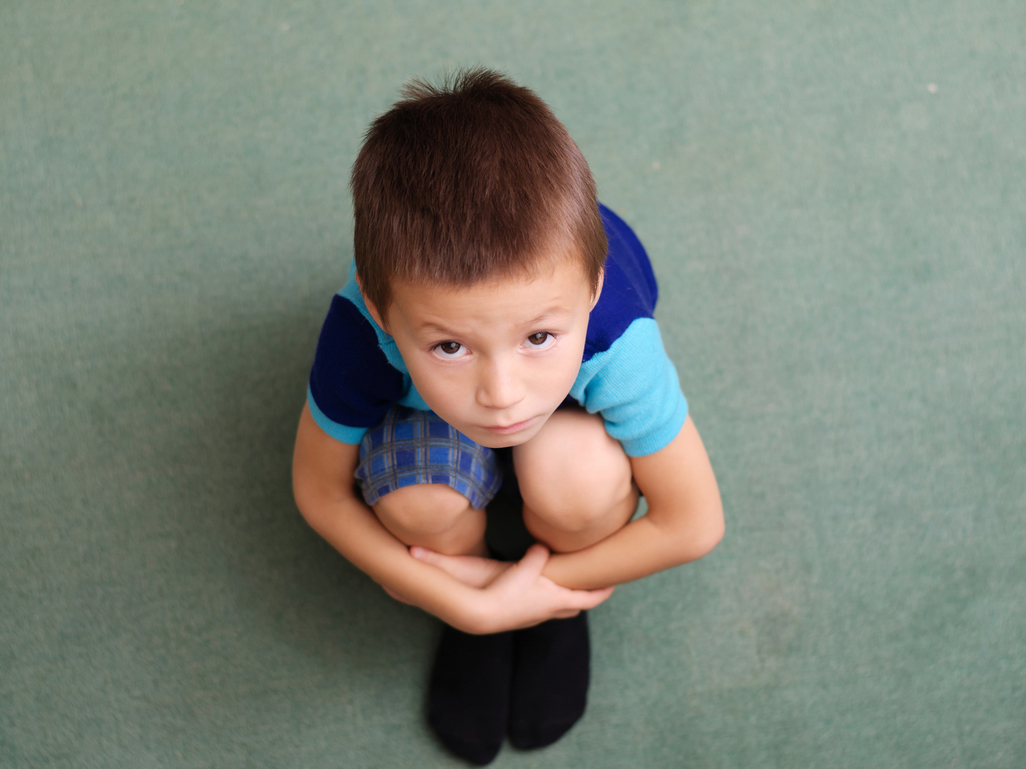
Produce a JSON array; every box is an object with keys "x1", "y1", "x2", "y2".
[{"x1": 0, "y1": 0, "x2": 1026, "y2": 769}]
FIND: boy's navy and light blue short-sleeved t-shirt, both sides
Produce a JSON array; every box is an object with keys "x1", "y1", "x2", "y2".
[{"x1": 308, "y1": 205, "x2": 687, "y2": 456}]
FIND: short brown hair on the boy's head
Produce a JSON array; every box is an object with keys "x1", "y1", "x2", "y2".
[{"x1": 351, "y1": 69, "x2": 607, "y2": 314}]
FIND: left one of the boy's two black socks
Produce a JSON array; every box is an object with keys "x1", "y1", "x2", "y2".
[{"x1": 428, "y1": 625, "x2": 513, "y2": 766}]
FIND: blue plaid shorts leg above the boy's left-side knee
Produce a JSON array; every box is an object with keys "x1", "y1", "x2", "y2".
[{"x1": 355, "y1": 406, "x2": 503, "y2": 510}]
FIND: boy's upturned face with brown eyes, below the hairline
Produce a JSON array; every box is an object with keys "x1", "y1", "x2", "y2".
[{"x1": 370, "y1": 259, "x2": 601, "y2": 448}]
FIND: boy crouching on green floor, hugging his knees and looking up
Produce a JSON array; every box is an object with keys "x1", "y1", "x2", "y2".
[{"x1": 293, "y1": 70, "x2": 723, "y2": 764}]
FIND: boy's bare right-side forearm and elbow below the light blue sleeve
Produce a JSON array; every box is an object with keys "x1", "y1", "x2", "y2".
[{"x1": 543, "y1": 416, "x2": 723, "y2": 589}]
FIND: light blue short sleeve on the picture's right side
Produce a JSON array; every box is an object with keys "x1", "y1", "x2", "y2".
[{"x1": 570, "y1": 318, "x2": 687, "y2": 456}]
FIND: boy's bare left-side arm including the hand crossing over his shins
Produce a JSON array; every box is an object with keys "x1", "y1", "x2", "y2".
[{"x1": 292, "y1": 406, "x2": 610, "y2": 633}]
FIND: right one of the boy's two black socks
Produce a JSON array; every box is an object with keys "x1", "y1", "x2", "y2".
[{"x1": 510, "y1": 611, "x2": 590, "y2": 750}]
